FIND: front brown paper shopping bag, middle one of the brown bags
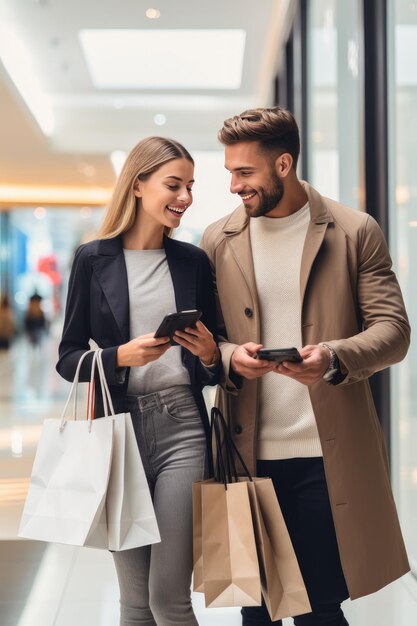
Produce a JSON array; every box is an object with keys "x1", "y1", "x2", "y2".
[{"x1": 200, "y1": 480, "x2": 261, "y2": 607}]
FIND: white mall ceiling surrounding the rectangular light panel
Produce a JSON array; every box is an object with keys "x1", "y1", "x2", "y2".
[{"x1": 0, "y1": 0, "x2": 291, "y2": 197}]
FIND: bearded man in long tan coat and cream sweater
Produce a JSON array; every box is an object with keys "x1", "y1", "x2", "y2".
[{"x1": 202, "y1": 107, "x2": 410, "y2": 626}]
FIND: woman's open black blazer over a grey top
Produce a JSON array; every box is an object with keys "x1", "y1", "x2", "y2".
[{"x1": 56, "y1": 236, "x2": 221, "y2": 432}]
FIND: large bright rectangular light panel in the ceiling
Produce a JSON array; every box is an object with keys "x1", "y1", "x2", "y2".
[{"x1": 79, "y1": 29, "x2": 246, "y2": 89}]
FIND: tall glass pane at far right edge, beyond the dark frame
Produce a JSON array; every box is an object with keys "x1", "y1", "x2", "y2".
[{"x1": 388, "y1": 0, "x2": 417, "y2": 574}]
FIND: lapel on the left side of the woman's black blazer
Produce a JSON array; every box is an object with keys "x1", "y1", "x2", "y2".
[{"x1": 90, "y1": 237, "x2": 129, "y2": 341}]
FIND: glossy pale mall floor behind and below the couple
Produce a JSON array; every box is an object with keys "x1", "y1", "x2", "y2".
[{"x1": 0, "y1": 341, "x2": 417, "y2": 626}]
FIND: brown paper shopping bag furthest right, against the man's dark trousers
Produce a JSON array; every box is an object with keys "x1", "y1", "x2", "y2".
[{"x1": 247, "y1": 478, "x2": 311, "y2": 620}]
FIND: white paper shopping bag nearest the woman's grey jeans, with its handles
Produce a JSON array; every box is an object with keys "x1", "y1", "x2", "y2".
[{"x1": 96, "y1": 350, "x2": 161, "y2": 551}]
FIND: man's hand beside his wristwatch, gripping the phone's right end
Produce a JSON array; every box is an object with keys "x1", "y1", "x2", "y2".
[{"x1": 275, "y1": 345, "x2": 330, "y2": 385}]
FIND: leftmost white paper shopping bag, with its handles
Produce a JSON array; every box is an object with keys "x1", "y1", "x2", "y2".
[{"x1": 19, "y1": 353, "x2": 114, "y2": 546}]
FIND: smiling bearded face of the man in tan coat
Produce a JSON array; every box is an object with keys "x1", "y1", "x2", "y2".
[{"x1": 225, "y1": 141, "x2": 284, "y2": 217}]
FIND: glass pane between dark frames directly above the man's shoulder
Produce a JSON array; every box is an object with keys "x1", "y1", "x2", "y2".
[{"x1": 307, "y1": 0, "x2": 363, "y2": 208}]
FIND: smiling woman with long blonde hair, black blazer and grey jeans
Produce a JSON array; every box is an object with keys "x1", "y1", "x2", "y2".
[{"x1": 57, "y1": 137, "x2": 221, "y2": 626}]
